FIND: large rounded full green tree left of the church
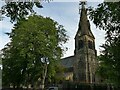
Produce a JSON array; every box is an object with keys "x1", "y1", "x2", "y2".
[{"x1": 2, "y1": 15, "x2": 68, "y2": 87}]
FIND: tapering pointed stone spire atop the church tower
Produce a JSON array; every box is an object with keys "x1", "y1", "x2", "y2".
[{"x1": 78, "y1": 1, "x2": 94, "y2": 38}]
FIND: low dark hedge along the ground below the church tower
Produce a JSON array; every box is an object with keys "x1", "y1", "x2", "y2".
[{"x1": 63, "y1": 82, "x2": 120, "y2": 90}]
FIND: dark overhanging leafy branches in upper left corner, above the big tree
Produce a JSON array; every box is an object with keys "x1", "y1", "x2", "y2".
[{"x1": 1, "y1": 0, "x2": 50, "y2": 22}]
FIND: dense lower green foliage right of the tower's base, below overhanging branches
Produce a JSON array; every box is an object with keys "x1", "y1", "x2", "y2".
[{"x1": 96, "y1": 43, "x2": 120, "y2": 85}]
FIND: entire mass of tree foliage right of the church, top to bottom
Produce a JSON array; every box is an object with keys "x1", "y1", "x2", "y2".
[{"x1": 90, "y1": 1, "x2": 120, "y2": 85}]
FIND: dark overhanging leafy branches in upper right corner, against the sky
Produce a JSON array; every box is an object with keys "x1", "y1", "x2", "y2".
[{"x1": 89, "y1": 2, "x2": 120, "y2": 40}]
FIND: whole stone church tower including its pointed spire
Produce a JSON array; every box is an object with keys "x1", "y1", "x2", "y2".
[{"x1": 73, "y1": 2, "x2": 96, "y2": 83}]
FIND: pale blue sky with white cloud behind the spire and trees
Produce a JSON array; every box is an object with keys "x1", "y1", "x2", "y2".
[{"x1": 0, "y1": 0, "x2": 105, "y2": 57}]
